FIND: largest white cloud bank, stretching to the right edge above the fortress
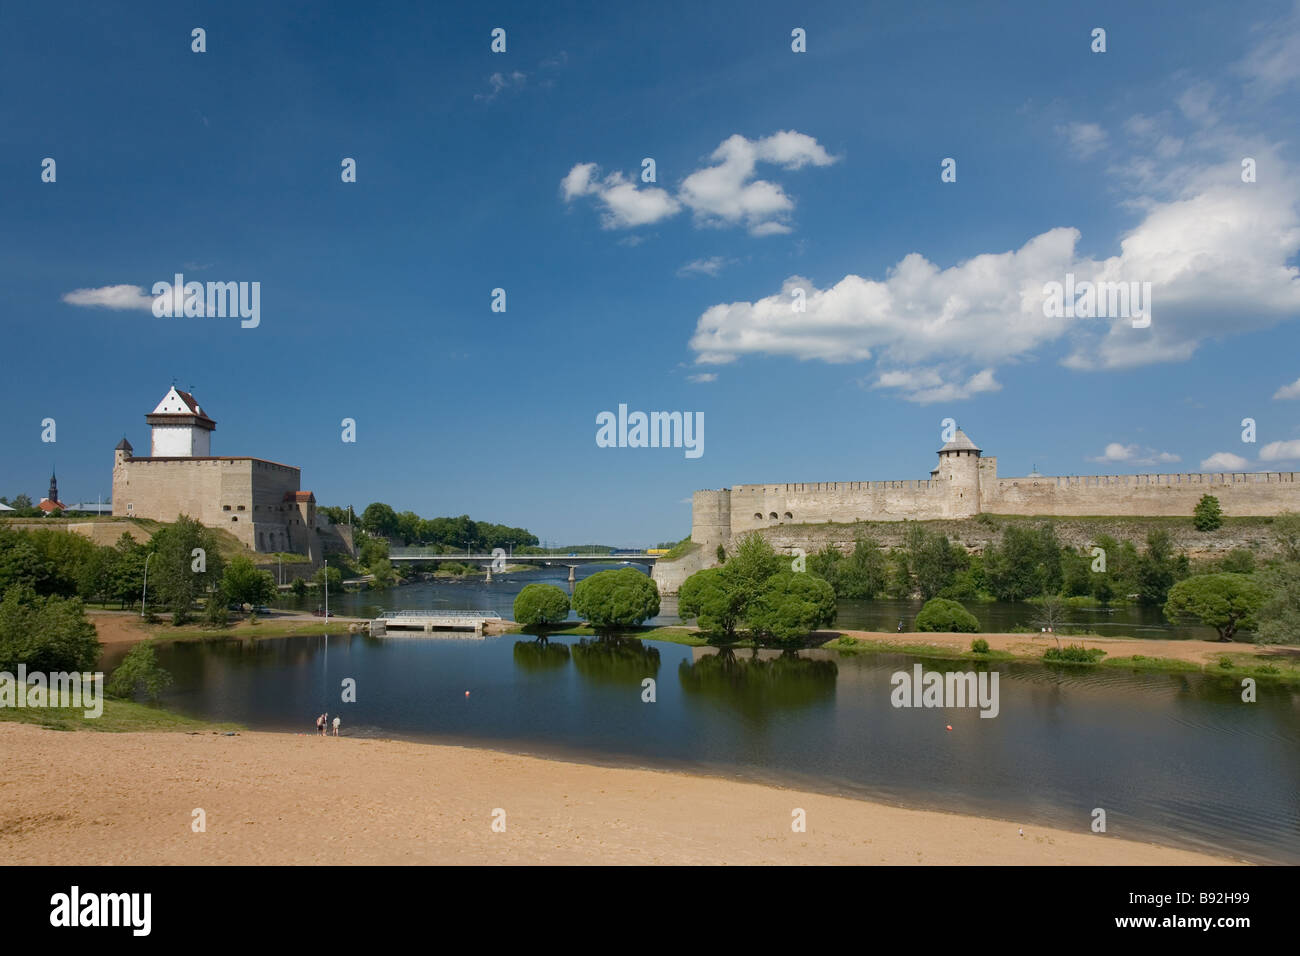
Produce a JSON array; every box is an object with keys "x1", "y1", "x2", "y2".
[{"x1": 689, "y1": 70, "x2": 1300, "y2": 401}]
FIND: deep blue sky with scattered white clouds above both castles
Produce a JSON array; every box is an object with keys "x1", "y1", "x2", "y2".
[{"x1": 0, "y1": 3, "x2": 1300, "y2": 544}]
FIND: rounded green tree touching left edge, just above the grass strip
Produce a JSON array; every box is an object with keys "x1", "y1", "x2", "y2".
[{"x1": 0, "y1": 585, "x2": 99, "y2": 674}]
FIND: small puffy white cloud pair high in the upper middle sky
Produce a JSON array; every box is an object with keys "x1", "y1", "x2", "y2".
[{"x1": 560, "y1": 130, "x2": 836, "y2": 235}]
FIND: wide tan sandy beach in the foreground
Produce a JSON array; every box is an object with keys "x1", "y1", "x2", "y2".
[{"x1": 0, "y1": 723, "x2": 1232, "y2": 865}]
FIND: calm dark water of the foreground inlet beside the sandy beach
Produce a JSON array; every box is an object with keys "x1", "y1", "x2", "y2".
[{"x1": 114, "y1": 635, "x2": 1300, "y2": 864}]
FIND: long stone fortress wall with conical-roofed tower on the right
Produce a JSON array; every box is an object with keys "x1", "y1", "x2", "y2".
[{"x1": 690, "y1": 429, "x2": 1300, "y2": 567}]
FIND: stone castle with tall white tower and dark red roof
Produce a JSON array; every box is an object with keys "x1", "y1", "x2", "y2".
[{"x1": 113, "y1": 385, "x2": 351, "y2": 563}]
